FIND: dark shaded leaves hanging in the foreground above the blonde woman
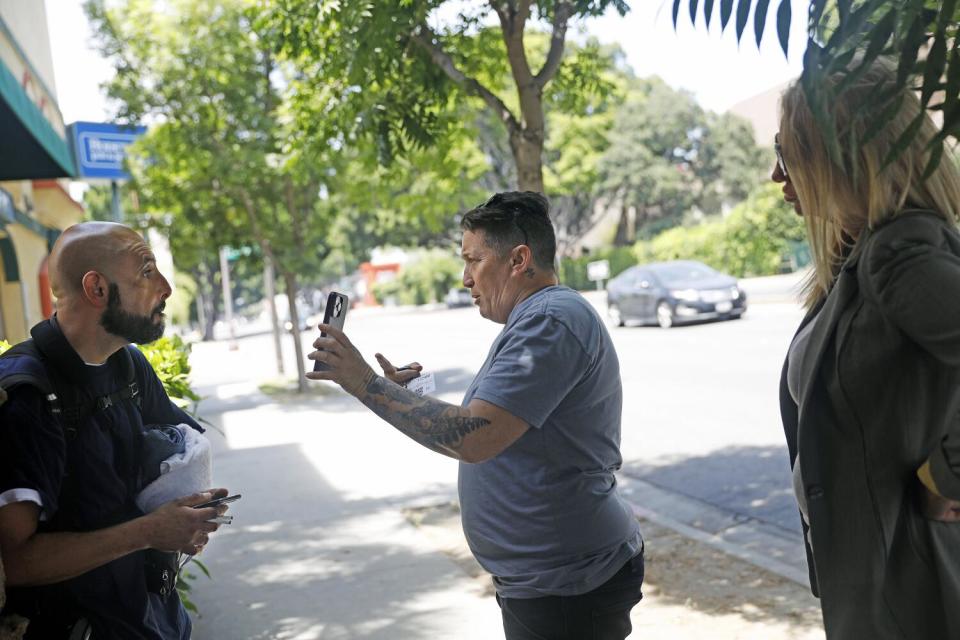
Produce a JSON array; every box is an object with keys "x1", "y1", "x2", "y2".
[{"x1": 673, "y1": 0, "x2": 960, "y2": 172}]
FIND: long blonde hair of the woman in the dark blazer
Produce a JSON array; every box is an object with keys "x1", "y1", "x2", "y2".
[{"x1": 780, "y1": 59, "x2": 960, "y2": 309}]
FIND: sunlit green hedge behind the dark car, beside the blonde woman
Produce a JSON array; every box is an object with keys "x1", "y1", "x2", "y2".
[{"x1": 634, "y1": 183, "x2": 806, "y2": 278}]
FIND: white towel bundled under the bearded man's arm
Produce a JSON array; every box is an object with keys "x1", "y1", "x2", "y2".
[{"x1": 137, "y1": 424, "x2": 213, "y2": 513}]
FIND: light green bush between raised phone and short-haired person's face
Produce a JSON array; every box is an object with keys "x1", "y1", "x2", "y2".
[{"x1": 373, "y1": 249, "x2": 463, "y2": 305}]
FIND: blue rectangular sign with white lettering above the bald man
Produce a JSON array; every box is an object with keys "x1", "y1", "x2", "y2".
[{"x1": 68, "y1": 122, "x2": 147, "y2": 180}]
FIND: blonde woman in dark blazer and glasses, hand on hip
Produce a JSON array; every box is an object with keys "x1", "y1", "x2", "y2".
[{"x1": 772, "y1": 61, "x2": 960, "y2": 640}]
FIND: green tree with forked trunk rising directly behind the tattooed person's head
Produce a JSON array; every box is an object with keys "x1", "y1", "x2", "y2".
[{"x1": 262, "y1": 0, "x2": 628, "y2": 192}]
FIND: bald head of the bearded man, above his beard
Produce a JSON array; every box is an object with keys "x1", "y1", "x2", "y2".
[{"x1": 49, "y1": 222, "x2": 146, "y2": 298}]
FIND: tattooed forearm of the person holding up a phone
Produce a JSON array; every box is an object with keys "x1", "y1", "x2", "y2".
[{"x1": 356, "y1": 376, "x2": 490, "y2": 459}]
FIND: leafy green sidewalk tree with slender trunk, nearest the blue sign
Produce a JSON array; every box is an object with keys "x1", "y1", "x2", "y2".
[{"x1": 86, "y1": 0, "x2": 333, "y2": 389}]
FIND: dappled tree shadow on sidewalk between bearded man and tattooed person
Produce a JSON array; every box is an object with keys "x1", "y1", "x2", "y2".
[{"x1": 187, "y1": 445, "x2": 495, "y2": 640}]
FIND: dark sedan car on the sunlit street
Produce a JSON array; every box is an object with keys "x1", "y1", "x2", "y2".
[{"x1": 607, "y1": 260, "x2": 747, "y2": 329}]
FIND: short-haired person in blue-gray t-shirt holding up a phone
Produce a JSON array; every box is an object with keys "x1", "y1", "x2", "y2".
[{"x1": 307, "y1": 192, "x2": 643, "y2": 640}]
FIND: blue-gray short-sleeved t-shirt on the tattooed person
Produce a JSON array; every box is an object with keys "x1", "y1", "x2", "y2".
[{"x1": 459, "y1": 286, "x2": 642, "y2": 598}]
